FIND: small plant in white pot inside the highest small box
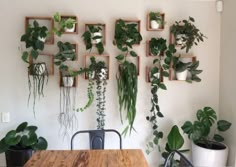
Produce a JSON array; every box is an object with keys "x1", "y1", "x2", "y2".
[{"x1": 149, "y1": 12, "x2": 165, "y2": 29}]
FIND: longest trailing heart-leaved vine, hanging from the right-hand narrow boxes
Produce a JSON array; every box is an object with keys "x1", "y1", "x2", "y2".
[{"x1": 146, "y1": 38, "x2": 176, "y2": 154}]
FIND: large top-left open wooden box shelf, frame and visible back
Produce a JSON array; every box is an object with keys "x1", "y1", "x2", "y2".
[{"x1": 25, "y1": 16, "x2": 54, "y2": 44}]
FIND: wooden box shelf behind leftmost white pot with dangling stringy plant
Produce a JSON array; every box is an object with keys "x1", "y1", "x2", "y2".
[{"x1": 29, "y1": 53, "x2": 54, "y2": 75}]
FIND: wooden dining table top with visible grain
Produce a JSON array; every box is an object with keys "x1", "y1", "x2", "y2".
[{"x1": 24, "y1": 149, "x2": 148, "y2": 167}]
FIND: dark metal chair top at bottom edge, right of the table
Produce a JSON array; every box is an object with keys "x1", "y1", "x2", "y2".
[{"x1": 164, "y1": 150, "x2": 194, "y2": 167}]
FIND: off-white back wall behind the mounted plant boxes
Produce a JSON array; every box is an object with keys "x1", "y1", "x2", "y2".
[{"x1": 0, "y1": 0, "x2": 220, "y2": 166}]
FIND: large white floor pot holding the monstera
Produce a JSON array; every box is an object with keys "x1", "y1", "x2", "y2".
[{"x1": 192, "y1": 143, "x2": 228, "y2": 167}]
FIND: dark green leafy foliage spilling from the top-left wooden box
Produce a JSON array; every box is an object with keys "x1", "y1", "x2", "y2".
[{"x1": 21, "y1": 20, "x2": 48, "y2": 63}]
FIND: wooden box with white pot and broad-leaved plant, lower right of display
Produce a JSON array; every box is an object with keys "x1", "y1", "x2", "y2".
[{"x1": 169, "y1": 56, "x2": 202, "y2": 83}]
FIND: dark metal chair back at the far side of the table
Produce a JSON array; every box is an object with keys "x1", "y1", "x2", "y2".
[{"x1": 71, "y1": 129, "x2": 122, "y2": 150}]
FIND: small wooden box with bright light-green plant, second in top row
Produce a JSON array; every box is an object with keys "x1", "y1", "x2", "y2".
[{"x1": 53, "y1": 12, "x2": 78, "y2": 37}]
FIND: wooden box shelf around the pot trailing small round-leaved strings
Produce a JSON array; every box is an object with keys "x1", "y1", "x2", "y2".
[{"x1": 84, "y1": 54, "x2": 110, "y2": 80}]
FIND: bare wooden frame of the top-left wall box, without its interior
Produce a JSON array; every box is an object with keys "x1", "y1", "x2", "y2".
[{"x1": 25, "y1": 16, "x2": 54, "y2": 44}]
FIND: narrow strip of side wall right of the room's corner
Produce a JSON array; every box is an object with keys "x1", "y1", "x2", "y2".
[{"x1": 219, "y1": 0, "x2": 236, "y2": 166}]
